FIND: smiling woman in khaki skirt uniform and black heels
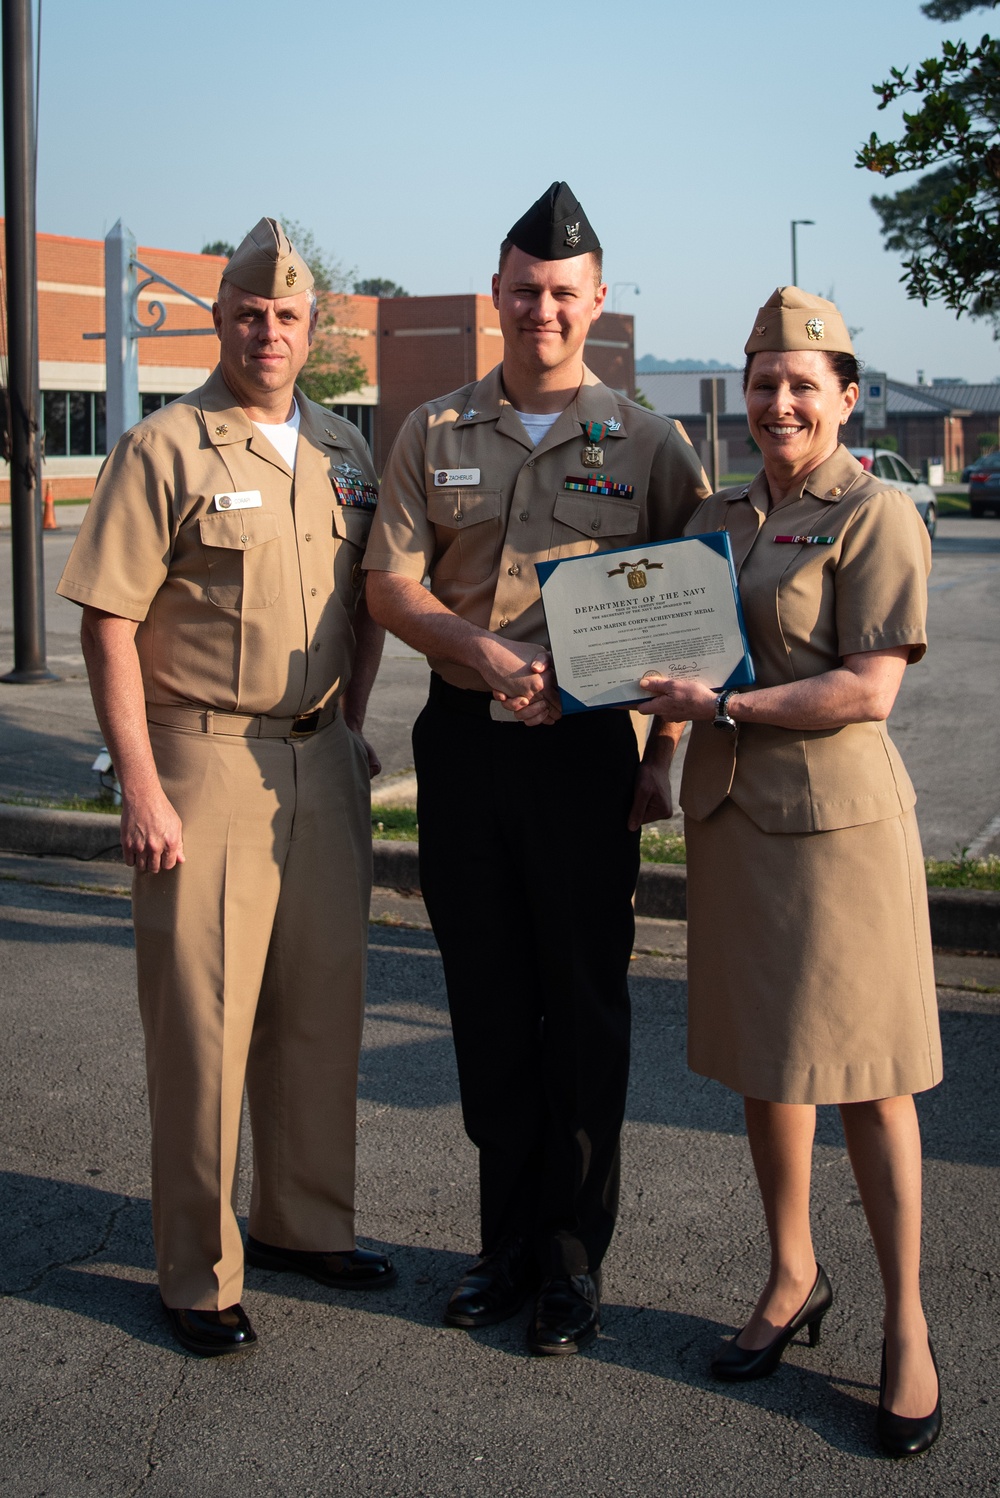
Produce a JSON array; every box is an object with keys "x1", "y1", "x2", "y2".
[{"x1": 642, "y1": 286, "x2": 942, "y2": 1456}]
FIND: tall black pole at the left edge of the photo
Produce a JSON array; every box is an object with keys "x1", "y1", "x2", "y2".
[{"x1": 0, "y1": 0, "x2": 55, "y2": 682}]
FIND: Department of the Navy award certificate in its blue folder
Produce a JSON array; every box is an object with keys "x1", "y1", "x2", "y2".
[{"x1": 536, "y1": 530, "x2": 753, "y2": 713}]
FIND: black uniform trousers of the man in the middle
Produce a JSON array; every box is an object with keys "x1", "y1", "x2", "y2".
[{"x1": 413, "y1": 677, "x2": 639, "y2": 1273}]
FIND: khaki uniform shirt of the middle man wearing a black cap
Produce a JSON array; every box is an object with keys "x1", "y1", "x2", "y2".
[{"x1": 364, "y1": 366, "x2": 708, "y2": 691}]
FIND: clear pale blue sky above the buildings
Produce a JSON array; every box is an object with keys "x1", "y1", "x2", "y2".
[{"x1": 15, "y1": 0, "x2": 1000, "y2": 380}]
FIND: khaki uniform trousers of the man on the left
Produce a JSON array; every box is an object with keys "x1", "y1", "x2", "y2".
[{"x1": 132, "y1": 715, "x2": 371, "y2": 1311}]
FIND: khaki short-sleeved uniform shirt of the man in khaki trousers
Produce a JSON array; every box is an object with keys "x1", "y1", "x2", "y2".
[{"x1": 58, "y1": 369, "x2": 376, "y2": 718}]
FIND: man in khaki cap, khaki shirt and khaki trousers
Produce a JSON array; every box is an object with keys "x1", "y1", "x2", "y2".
[{"x1": 58, "y1": 219, "x2": 395, "y2": 1356}]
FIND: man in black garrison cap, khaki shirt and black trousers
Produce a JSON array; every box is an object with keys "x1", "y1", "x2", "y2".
[{"x1": 365, "y1": 183, "x2": 707, "y2": 1353}]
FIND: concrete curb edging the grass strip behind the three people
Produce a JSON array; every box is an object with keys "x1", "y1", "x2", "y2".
[{"x1": 0, "y1": 804, "x2": 1000, "y2": 953}]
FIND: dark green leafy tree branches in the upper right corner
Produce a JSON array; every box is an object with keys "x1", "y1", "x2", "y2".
[{"x1": 856, "y1": 0, "x2": 1000, "y2": 328}]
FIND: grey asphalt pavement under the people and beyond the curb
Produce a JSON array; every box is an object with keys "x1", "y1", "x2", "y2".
[{"x1": 0, "y1": 521, "x2": 1000, "y2": 1498}]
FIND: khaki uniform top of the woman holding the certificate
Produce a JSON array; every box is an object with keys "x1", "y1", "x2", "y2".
[{"x1": 681, "y1": 446, "x2": 931, "y2": 833}]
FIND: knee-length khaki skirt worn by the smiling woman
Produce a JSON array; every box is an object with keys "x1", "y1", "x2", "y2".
[{"x1": 686, "y1": 800, "x2": 942, "y2": 1103}]
